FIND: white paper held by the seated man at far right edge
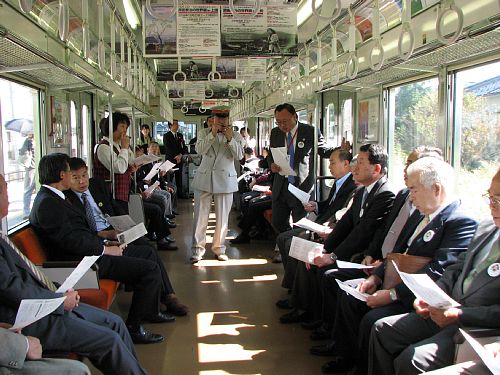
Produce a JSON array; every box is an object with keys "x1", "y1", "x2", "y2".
[{"x1": 392, "y1": 261, "x2": 460, "y2": 309}]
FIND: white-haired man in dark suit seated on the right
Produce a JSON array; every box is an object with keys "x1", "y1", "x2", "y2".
[{"x1": 322, "y1": 158, "x2": 477, "y2": 374}]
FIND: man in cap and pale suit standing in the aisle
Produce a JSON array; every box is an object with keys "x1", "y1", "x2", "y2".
[{"x1": 191, "y1": 106, "x2": 243, "y2": 263}]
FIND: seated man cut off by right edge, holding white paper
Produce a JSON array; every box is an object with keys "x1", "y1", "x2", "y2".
[{"x1": 369, "y1": 170, "x2": 500, "y2": 374}]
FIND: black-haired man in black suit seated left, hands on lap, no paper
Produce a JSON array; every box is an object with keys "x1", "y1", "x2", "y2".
[{"x1": 30, "y1": 153, "x2": 175, "y2": 343}]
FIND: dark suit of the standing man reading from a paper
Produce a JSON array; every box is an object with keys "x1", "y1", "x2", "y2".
[{"x1": 268, "y1": 122, "x2": 331, "y2": 233}]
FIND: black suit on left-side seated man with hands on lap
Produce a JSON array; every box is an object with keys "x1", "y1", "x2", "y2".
[{"x1": 30, "y1": 186, "x2": 167, "y2": 325}]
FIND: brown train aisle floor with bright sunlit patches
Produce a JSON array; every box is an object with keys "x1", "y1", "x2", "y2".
[{"x1": 87, "y1": 199, "x2": 334, "y2": 375}]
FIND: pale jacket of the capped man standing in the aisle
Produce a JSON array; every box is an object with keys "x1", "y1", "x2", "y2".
[{"x1": 193, "y1": 129, "x2": 243, "y2": 193}]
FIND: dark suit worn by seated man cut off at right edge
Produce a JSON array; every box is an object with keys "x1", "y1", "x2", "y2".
[{"x1": 370, "y1": 219, "x2": 500, "y2": 374}]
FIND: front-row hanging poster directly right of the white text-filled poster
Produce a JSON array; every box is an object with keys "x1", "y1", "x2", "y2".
[{"x1": 220, "y1": 6, "x2": 267, "y2": 56}]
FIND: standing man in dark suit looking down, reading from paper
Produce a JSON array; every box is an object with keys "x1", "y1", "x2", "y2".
[{"x1": 268, "y1": 103, "x2": 332, "y2": 233}]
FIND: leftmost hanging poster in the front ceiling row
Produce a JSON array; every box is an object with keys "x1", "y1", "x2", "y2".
[{"x1": 142, "y1": 5, "x2": 177, "y2": 57}]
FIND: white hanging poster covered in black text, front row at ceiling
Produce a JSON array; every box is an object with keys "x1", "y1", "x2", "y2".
[{"x1": 177, "y1": 5, "x2": 221, "y2": 56}]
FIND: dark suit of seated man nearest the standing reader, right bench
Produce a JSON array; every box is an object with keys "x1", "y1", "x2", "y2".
[{"x1": 276, "y1": 174, "x2": 356, "y2": 289}]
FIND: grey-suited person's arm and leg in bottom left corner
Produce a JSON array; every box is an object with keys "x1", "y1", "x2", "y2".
[{"x1": 0, "y1": 323, "x2": 90, "y2": 375}]
